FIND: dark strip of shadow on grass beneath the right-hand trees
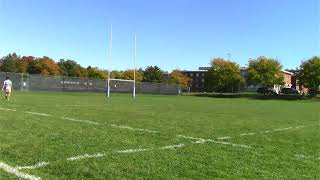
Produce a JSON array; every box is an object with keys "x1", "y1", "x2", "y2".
[{"x1": 193, "y1": 93, "x2": 320, "y2": 102}]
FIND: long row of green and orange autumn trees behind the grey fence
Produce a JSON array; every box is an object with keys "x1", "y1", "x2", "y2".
[{"x1": 0, "y1": 53, "x2": 191, "y2": 86}]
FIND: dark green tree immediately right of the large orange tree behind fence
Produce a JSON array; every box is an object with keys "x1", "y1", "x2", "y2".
[{"x1": 58, "y1": 59, "x2": 86, "y2": 78}]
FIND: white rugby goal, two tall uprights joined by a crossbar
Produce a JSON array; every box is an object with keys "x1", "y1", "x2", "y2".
[{"x1": 106, "y1": 25, "x2": 137, "y2": 99}]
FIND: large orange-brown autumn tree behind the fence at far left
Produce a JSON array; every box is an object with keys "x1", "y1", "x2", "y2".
[{"x1": 29, "y1": 56, "x2": 60, "y2": 76}]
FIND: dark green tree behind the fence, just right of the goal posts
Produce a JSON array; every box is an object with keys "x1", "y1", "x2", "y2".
[{"x1": 143, "y1": 66, "x2": 164, "y2": 83}]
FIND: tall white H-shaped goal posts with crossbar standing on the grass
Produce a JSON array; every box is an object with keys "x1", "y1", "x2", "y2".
[{"x1": 106, "y1": 25, "x2": 137, "y2": 99}]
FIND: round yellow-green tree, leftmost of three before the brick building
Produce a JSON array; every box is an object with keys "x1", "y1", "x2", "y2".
[{"x1": 205, "y1": 58, "x2": 243, "y2": 92}]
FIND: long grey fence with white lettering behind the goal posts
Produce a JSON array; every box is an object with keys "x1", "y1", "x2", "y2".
[{"x1": 0, "y1": 72, "x2": 181, "y2": 95}]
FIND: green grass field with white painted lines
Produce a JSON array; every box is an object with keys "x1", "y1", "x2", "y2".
[{"x1": 0, "y1": 92, "x2": 320, "y2": 179}]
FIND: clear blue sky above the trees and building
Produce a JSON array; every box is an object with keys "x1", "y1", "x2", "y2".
[{"x1": 0, "y1": 0, "x2": 320, "y2": 71}]
